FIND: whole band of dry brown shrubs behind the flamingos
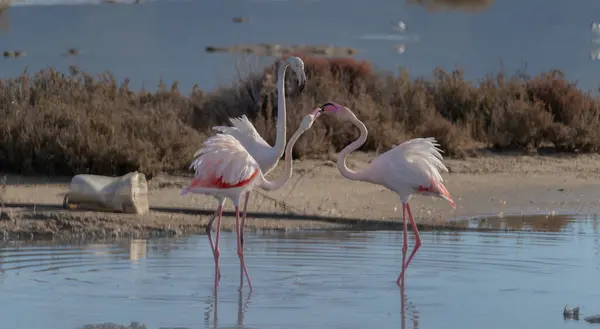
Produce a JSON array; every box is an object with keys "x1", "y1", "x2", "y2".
[{"x1": 0, "y1": 56, "x2": 600, "y2": 177}]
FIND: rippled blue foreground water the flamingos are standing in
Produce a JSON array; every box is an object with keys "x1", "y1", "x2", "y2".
[{"x1": 0, "y1": 216, "x2": 600, "y2": 329}]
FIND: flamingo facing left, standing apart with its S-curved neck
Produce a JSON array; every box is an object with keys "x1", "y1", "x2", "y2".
[{"x1": 313, "y1": 102, "x2": 456, "y2": 285}]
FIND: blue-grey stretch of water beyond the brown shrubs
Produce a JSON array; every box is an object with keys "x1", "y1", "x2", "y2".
[{"x1": 0, "y1": 0, "x2": 600, "y2": 91}]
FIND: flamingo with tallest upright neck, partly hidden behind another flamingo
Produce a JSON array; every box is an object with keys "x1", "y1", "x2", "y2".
[{"x1": 211, "y1": 56, "x2": 306, "y2": 246}]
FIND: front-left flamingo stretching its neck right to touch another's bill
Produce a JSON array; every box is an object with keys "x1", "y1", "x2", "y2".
[{"x1": 181, "y1": 113, "x2": 316, "y2": 291}]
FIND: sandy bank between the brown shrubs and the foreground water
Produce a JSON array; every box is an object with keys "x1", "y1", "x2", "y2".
[{"x1": 0, "y1": 153, "x2": 600, "y2": 238}]
